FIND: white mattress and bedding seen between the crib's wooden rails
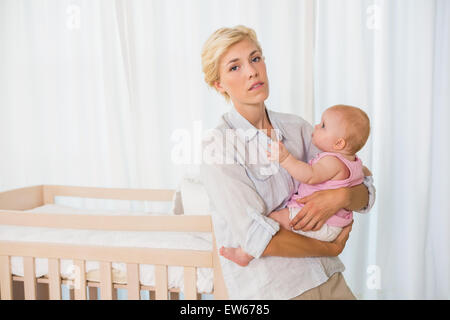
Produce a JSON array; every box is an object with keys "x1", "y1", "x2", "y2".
[{"x1": 0, "y1": 204, "x2": 213, "y2": 293}]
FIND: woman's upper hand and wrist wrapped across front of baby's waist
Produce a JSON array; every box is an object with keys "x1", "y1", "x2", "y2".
[{"x1": 290, "y1": 188, "x2": 348, "y2": 231}]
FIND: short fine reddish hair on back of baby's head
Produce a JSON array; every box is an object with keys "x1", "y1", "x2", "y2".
[{"x1": 328, "y1": 104, "x2": 370, "y2": 154}]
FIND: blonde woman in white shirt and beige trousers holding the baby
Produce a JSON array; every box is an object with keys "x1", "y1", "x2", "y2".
[{"x1": 201, "y1": 26, "x2": 374, "y2": 299}]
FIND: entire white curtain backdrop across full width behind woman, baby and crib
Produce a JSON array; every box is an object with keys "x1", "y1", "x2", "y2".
[{"x1": 0, "y1": 0, "x2": 450, "y2": 299}]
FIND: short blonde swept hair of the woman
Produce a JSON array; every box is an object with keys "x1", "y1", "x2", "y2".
[{"x1": 202, "y1": 25, "x2": 262, "y2": 101}]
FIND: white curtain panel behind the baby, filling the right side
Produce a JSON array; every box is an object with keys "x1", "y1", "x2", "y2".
[{"x1": 314, "y1": 0, "x2": 450, "y2": 299}]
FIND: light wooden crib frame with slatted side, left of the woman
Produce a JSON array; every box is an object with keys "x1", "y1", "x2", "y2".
[{"x1": 0, "y1": 185, "x2": 228, "y2": 300}]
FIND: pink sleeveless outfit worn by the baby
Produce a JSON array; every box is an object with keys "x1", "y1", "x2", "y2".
[{"x1": 287, "y1": 152, "x2": 364, "y2": 228}]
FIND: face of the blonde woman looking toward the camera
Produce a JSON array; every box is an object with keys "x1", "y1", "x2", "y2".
[{"x1": 215, "y1": 39, "x2": 269, "y2": 106}]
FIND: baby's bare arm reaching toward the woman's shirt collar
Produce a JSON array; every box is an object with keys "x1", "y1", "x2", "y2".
[{"x1": 268, "y1": 142, "x2": 343, "y2": 184}]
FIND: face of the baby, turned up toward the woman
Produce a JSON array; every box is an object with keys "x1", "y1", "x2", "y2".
[{"x1": 312, "y1": 110, "x2": 345, "y2": 152}]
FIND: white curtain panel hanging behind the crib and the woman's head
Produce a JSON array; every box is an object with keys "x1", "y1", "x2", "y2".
[{"x1": 0, "y1": 0, "x2": 313, "y2": 211}]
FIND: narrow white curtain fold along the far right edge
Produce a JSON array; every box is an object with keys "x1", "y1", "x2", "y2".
[{"x1": 423, "y1": 0, "x2": 450, "y2": 299}]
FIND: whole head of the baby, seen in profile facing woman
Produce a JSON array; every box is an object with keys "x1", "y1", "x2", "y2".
[{"x1": 312, "y1": 105, "x2": 370, "y2": 155}]
